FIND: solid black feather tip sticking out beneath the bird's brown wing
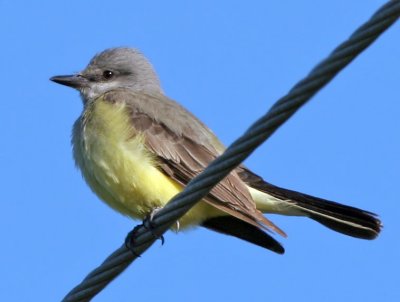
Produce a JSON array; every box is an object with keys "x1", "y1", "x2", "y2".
[{"x1": 202, "y1": 216, "x2": 285, "y2": 254}]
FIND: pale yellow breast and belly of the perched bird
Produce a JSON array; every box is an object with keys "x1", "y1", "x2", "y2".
[{"x1": 73, "y1": 100, "x2": 222, "y2": 228}]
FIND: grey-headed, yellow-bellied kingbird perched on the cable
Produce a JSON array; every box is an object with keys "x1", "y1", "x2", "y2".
[{"x1": 51, "y1": 48, "x2": 381, "y2": 254}]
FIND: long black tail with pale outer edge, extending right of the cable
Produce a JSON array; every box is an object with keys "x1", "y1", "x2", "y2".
[{"x1": 239, "y1": 167, "x2": 382, "y2": 239}]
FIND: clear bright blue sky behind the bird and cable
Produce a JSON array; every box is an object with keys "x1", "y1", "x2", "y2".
[{"x1": 0, "y1": 0, "x2": 400, "y2": 302}]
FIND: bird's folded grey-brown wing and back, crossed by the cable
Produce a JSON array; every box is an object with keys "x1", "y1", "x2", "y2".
[{"x1": 111, "y1": 91, "x2": 285, "y2": 236}]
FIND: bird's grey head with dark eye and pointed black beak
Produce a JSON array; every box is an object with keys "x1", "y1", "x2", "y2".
[{"x1": 50, "y1": 47, "x2": 162, "y2": 102}]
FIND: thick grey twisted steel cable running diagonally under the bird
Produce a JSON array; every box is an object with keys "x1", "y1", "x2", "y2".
[{"x1": 62, "y1": 0, "x2": 400, "y2": 302}]
